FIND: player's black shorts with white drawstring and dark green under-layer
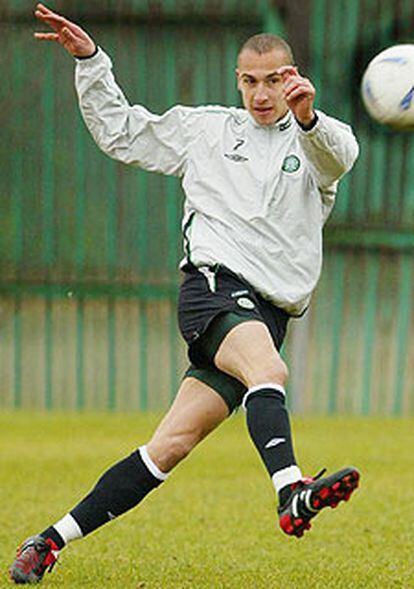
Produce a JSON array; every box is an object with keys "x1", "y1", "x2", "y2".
[{"x1": 178, "y1": 264, "x2": 289, "y2": 411}]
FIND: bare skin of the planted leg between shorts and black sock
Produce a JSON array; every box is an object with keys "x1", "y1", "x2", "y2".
[{"x1": 147, "y1": 377, "x2": 229, "y2": 472}]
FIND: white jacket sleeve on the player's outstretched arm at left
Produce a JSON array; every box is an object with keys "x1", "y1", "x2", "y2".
[{"x1": 75, "y1": 49, "x2": 193, "y2": 176}]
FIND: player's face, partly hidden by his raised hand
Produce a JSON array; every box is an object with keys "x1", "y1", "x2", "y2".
[{"x1": 236, "y1": 49, "x2": 291, "y2": 125}]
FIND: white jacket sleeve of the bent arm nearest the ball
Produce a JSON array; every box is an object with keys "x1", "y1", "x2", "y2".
[{"x1": 299, "y1": 111, "x2": 359, "y2": 191}]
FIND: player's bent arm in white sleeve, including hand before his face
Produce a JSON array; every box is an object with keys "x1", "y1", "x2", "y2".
[{"x1": 278, "y1": 66, "x2": 359, "y2": 190}]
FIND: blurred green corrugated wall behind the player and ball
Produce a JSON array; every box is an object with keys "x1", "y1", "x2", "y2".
[{"x1": 0, "y1": 0, "x2": 414, "y2": 415}]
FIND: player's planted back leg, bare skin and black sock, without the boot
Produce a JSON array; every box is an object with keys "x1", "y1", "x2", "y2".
[{"x1": 41, "y1": 378, "x2": 228, "y2": 549}]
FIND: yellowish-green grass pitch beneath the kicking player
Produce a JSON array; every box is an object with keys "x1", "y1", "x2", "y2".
[{"x1": 0, "y1": 413, "x2": 414, "y2": 589}]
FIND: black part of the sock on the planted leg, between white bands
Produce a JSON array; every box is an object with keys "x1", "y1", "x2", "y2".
[{"x1": 70, "y1": 451, "x2": 163, "y2": 536}]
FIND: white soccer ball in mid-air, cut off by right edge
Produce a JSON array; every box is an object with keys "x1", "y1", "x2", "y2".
[{"x1": 361, "y1": 44, "x2": 414, "y2": 129}]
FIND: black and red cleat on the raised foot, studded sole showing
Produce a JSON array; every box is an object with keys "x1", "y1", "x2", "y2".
[{"x1": 278, "y1": 466, "x2": 360, "y2": 538}]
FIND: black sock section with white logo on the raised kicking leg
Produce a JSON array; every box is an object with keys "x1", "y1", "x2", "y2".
[{"x1": 245, "y1": 387, "x2": 296, "y2": 476}]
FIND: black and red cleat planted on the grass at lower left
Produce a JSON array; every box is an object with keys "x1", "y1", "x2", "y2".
[{"x1": 9, "y1": 536, "x2": 59, "y2": 585}]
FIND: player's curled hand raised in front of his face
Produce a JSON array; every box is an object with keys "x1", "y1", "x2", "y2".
[{"x1": 277, "y1": 65, "x2": 316, "y2": 125}]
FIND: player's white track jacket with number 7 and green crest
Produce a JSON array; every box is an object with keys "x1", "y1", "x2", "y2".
[{"x1": 75, "y1": 49, "x2": 358, "y2": 315}]
